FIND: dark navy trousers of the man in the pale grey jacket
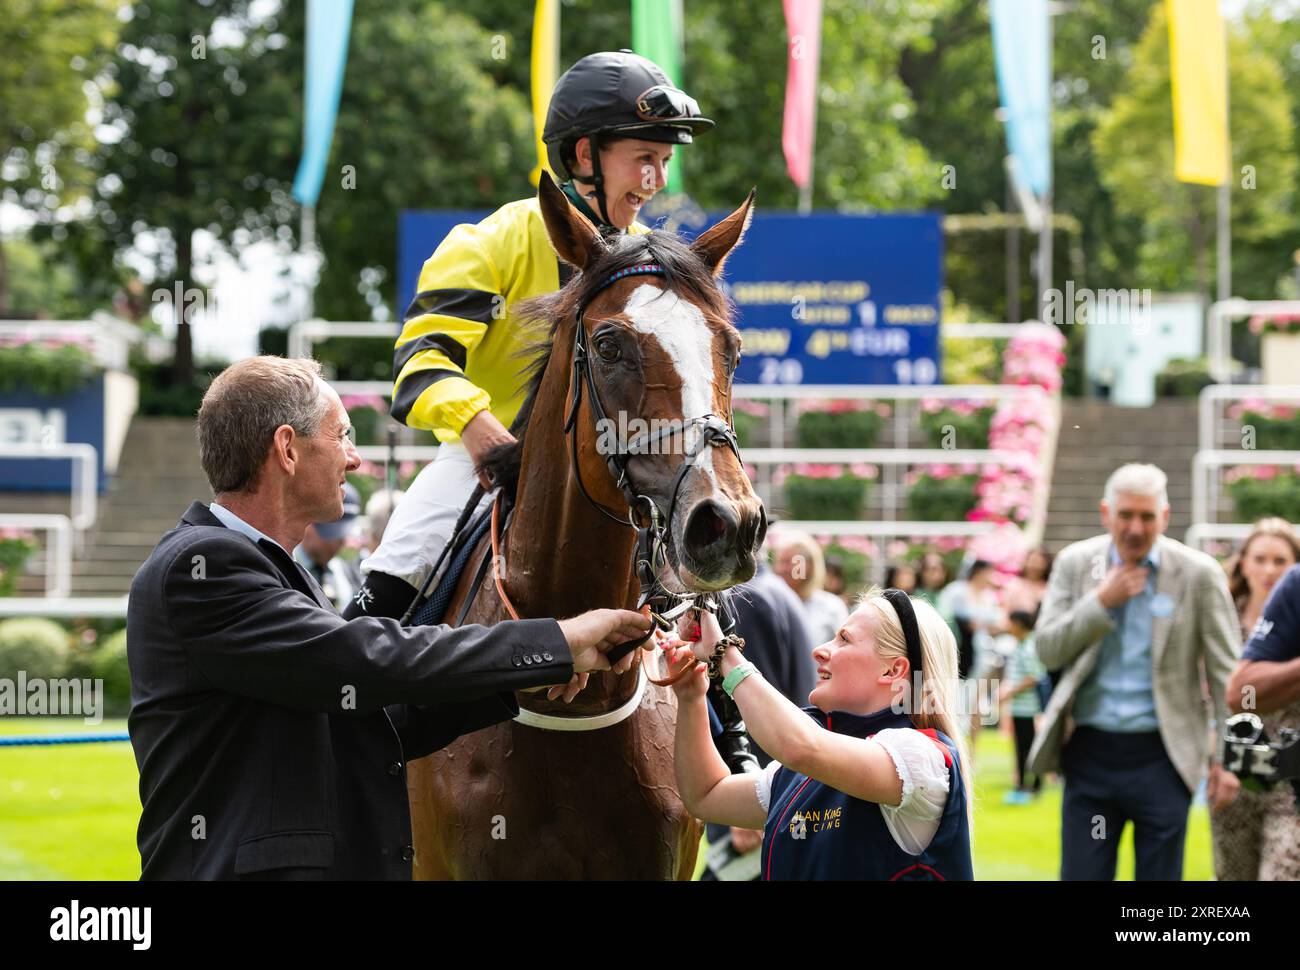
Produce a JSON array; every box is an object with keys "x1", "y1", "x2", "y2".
[{"x1": 1061, "y1": 727, "x2": 1192, "y2": 880}]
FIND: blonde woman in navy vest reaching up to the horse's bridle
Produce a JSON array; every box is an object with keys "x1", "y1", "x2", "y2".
[{"x1": 668, "y1": 588, "x2": 972, "y2": 880}]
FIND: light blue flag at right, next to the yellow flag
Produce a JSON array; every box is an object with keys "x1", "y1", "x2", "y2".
[{"x1": 992, "y1": 0, "x2": 1052, "y2": 199}]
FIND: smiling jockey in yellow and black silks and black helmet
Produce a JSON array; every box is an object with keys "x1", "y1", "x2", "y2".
[{"x1": 345, "y1": 51, "x2": 757, "y2": 768}]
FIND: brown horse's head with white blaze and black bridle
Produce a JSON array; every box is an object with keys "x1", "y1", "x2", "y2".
[{"x1": 538, "y1": 177, "x2": 767, "y2": 593}]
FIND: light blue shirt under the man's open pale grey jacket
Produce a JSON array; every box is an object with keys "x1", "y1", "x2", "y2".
[{"x1": 1074, "y1": 540, "x2": 1160, "y2": 733}]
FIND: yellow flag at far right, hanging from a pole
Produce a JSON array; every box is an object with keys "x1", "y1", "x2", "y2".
[{"x1": 1165, "y1": 0, "x2": 1230, "y2": 185}]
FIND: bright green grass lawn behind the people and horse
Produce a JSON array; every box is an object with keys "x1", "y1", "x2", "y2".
[{"x1": 0, "y1": 718, "x2": 1213, "y2": 880}]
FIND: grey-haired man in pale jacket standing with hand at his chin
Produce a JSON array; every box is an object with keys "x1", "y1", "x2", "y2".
[{"x1": 1030, "y1": 464, "x2": 1242, "y2": 879}]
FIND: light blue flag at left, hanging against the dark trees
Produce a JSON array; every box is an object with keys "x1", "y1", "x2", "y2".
[{"x1": 294, "y1": 0, "x2": 352, "y2": 205}]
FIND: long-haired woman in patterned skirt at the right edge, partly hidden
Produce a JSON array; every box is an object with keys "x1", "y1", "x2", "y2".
[{"x1": 1210, "y1": 519, "x2": 1300, "y2": 882}]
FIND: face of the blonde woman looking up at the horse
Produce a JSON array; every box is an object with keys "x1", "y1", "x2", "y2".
[{"x1": 809, "y1": 607, "x2": 907, "y2": 714}]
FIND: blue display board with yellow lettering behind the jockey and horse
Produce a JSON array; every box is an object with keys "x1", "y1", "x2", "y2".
[{"x1": 398, "y1": 211, "x2": 943, "y2": 385}]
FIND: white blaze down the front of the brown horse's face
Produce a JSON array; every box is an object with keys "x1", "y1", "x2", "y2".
[{"x1": 623, "y1": 283, "x2": 718, "y2": 490}]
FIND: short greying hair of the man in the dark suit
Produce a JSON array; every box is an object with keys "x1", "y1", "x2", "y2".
[{"x1": 199, "y1": 356, "x2": 330, "y2": 495}]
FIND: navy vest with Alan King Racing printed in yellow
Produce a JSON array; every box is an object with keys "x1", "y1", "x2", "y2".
[{"x1": 762, "y1": 707, "x2": 975, "y2": 880}]
